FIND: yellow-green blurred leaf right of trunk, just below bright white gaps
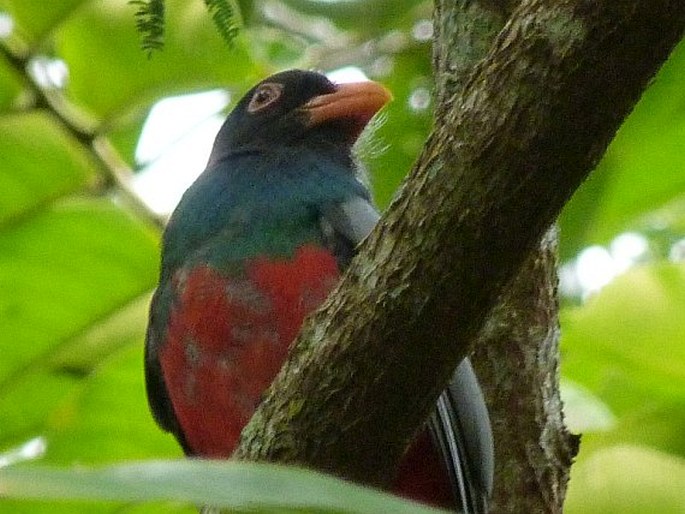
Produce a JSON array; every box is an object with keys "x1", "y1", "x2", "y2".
[{"x1": 561, "y1": 263, "x2": 685, "y2": 456}]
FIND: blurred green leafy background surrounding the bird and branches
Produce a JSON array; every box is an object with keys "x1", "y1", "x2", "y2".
[{"x1": 0, "y1": 0, "x2": 685, "y2": 514}]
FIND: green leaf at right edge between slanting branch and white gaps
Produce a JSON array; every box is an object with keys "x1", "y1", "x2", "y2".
[{"x1": 560, "y1": 42, "x2": 685, "y2": 259}]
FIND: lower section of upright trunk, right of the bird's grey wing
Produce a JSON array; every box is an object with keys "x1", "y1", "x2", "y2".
[{"x1": 472, "y1": 229, "x2": 579, "y2": 514}]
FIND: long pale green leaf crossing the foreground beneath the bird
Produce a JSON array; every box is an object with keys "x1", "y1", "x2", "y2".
[{"x1": 0, "y1": 460, "x2": 444, "y2": 514}]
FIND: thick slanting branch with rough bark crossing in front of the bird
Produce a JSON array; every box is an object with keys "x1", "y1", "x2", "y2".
[{"x1": 236, "y1": 0, "x2": 685, "y2": 495}]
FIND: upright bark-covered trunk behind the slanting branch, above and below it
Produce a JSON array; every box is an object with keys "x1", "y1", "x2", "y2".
[{"x1": 433, "y1": 0, "x2": 579, "y2": 514}]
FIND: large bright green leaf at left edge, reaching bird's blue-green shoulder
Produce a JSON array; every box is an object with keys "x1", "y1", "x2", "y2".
[{"x1": 0, "y1": 200, "x2": 158, "y2": 446}]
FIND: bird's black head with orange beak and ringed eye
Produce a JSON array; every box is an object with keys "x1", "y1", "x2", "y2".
[{"x1": 209, "y1": 70, "x2": 392, "y2": 166}]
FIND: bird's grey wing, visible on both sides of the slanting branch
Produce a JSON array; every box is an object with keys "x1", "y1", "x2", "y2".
[{"x1": 323, "y1": 196, "x2": 494, "y2": 514}]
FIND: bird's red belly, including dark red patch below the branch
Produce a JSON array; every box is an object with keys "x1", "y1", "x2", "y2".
[{"x1": 160, "y1": 242, "x2": 453, "y2": 507}]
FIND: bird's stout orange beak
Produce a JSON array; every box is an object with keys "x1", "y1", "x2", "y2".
[{"x1": 302, "y1": 81, "x2": 392, "y2": 138}]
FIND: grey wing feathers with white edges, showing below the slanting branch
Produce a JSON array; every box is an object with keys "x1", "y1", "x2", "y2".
[{"x1": 429, "y1": 358, "x2": 494, "y2": 514}]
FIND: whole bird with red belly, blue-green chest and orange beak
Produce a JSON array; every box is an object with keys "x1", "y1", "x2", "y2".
[{"x1": 145, "y1": 70, "x2": 494, "y2": 513}]
